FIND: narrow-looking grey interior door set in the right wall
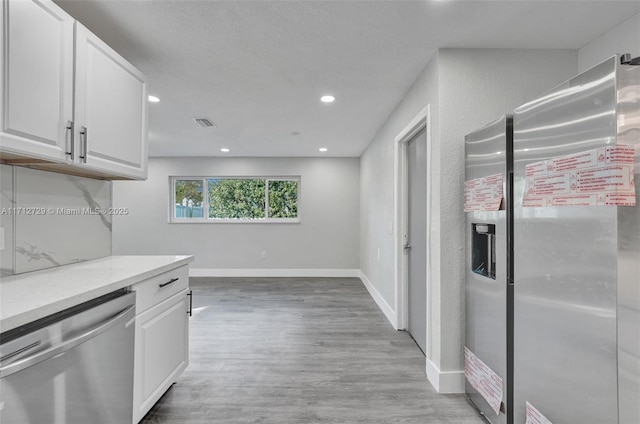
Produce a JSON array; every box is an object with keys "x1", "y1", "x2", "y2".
[{"x1": 405, "y1": 128, "x2": 427, "y2": 353}]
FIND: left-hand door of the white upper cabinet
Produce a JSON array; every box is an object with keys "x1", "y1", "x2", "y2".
[{"x1": 0, "y1": 0, "x2": 73, "y2": 162}]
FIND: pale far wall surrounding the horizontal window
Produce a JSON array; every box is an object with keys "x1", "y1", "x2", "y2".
[{"x1": 113, "y1": 158, "x2": 360, "y2": 275}]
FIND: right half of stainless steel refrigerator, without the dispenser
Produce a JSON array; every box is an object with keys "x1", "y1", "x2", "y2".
[{"x1": 513, "y1": 56, "x2": 640, "y2": 424}]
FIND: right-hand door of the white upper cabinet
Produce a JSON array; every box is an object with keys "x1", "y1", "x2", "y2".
[{"x1": 75, "y1": 22, "x2": 147, "y2": 179}]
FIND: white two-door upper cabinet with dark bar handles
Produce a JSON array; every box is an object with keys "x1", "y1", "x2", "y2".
[{"x1": 0, "y1": 0, "x2": 147, "y2": 179}]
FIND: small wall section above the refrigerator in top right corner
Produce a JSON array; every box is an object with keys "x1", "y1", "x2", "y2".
[{"x1": 578, "y1": 13, "x2": 640, "y2": 72}]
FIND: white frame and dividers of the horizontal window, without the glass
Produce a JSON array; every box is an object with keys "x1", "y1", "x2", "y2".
[{"x1": 169, "y1": 175, "x2": 302, "y2": 224}]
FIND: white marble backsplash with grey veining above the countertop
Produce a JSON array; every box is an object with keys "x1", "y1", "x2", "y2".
[{"x1": 2, "y1": 165, "x2": 112, "y2": 274}]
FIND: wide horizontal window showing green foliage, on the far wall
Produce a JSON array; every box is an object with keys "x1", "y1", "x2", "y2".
[{"x1": 170, "y1": 177, "x2": 300, "y2": 222}]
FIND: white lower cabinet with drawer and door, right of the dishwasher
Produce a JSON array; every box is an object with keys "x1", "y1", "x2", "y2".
[{"x1": 132, "y1": 266, "x2": 191, "y2": 424}]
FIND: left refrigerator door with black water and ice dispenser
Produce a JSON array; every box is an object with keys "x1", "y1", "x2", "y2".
[{"x1": 465, "y1": 116, "x2": 512, "y2": 424}]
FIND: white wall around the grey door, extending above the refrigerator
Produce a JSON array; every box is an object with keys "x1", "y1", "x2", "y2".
[{"x1": 360, "y1": 49, "x2": 577, "y2": 392}]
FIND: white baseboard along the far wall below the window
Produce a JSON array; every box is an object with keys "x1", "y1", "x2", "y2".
[{"x1": 189, "y1": 268, "x2": 360, "y2": 278}]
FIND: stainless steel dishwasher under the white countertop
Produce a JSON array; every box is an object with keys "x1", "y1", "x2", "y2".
[{"x1": 0, "y1": 290, "x2": 135, "y2": 424}]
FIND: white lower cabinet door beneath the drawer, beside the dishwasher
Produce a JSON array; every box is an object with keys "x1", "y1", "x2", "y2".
[{"x1": 133, "y1": 290, "x2": 189, "y2": 423}]
